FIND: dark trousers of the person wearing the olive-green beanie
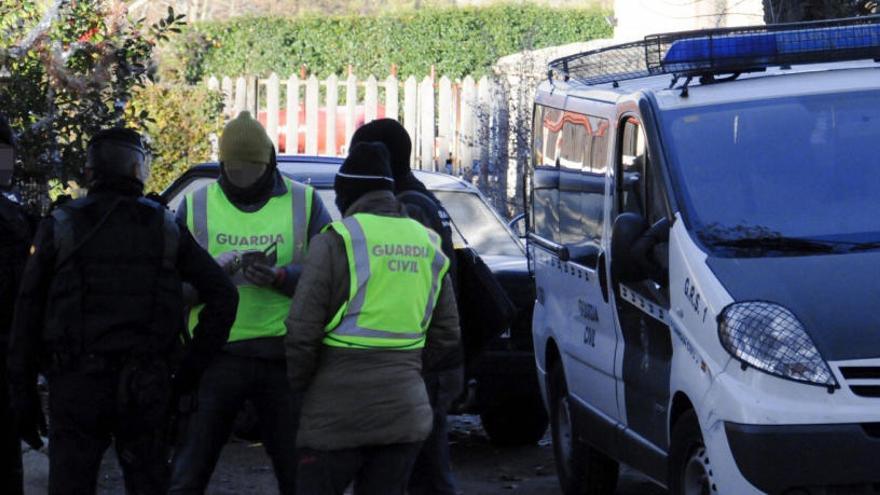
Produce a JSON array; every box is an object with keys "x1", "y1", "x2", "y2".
[{"x1": 169, "y1": 353, "x2": 300, "y2": 495}]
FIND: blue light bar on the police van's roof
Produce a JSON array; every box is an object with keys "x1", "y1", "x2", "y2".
[{"x1": 662, "y1": 24, "x2": 880, "y2": 72}]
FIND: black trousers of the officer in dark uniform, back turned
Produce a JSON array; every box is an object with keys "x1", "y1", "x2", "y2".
[{"x1": 49, "y1": 371, "x2": 170, "y2": 495}]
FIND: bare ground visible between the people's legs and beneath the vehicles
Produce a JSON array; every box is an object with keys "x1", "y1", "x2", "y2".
[{"x1": 24, "y1": 416, "x2": 665, "y2": 495}]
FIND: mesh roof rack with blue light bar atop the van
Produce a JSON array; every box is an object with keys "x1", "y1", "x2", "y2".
[{"x1": 548, "y1": 15, "x2": 880, "y2": 85}]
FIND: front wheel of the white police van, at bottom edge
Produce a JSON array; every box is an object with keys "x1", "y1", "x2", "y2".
[{"x1": 669, "y1": 410, "x2": 718, "y2": 495}]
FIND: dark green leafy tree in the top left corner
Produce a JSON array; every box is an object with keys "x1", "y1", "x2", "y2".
[{"x1": 0, "y1": 0, "x2": 185, "y2": 192}]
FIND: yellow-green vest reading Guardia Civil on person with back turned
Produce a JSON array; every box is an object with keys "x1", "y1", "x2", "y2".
[{"x1": 324, "y1": 213, "x2": 449, "y2": 350}]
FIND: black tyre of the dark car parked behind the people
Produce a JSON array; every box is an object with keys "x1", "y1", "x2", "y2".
[{"x1": 480, "y1": 396, "x2": 549, "y2": 447}]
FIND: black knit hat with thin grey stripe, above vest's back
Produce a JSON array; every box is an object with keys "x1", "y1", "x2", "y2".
[{"x1": 333, "y1": 142, "x2": 394, "y2": 215}]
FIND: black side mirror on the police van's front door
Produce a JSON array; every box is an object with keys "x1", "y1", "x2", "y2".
[{"x1": 611, "y1": 213, "x2": 669, "y2": 285}]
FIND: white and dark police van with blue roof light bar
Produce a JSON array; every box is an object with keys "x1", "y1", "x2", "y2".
[{"x1": 525, "y1": 17, "x2": 880, "y2": 495}]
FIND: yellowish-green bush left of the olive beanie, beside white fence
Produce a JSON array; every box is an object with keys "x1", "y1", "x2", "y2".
[{"x1": 130, "y1": 84, "x2": 224, "y2": 192}]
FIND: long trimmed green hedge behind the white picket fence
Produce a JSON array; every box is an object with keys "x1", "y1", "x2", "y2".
[{"x1": 163, "y1": 5, "x2": 611, "y2": 82}]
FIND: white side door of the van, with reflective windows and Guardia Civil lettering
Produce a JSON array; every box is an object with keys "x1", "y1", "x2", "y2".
[{"x1": 530, "y1": 107, "x2": 619, "y2": 426}]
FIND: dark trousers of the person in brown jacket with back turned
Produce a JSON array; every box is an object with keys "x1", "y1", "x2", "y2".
[{"x1": 297, "y1": 442, "x2": 422, "y2": 495}]
